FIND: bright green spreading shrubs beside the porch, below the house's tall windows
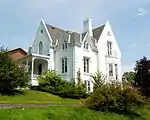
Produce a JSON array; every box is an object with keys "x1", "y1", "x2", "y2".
[{"x1": 36, "y1": 70, "x2": 87, "y2": 99}]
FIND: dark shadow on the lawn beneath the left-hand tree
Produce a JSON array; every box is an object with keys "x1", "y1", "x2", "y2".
[{"x1": 0, "y1": 90, "x2": 25, "y2": 96}]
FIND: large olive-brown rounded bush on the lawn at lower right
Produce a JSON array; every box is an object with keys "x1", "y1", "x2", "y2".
[{"x1": 86, "y1": 71, "x2": 146, "y2": 113}]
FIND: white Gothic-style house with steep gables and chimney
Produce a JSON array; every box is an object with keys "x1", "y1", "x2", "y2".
[{"x1": 20, "y1": 19, "x2": 121, "y2": 91}]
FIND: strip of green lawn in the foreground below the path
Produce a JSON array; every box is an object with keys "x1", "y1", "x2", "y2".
[{"x1": 0, "y1": 107, "x2": 150, "y2": 120}]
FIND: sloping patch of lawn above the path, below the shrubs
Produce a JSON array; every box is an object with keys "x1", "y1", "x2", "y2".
[{"x1": 0, "y1": 90, "x2": 81, "y2": 104}]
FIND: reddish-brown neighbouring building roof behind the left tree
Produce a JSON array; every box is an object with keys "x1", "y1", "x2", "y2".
[{"x1": 8, "y1": 48, "x2": 27, "y2": 61}]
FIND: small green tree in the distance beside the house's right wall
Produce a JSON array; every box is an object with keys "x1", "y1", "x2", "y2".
[{"x1": 122, "y1": 71, "x2": 136, "y2": 85}]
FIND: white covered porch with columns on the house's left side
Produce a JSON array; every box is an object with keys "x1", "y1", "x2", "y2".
[{"x1": 19, "y1": 54, "x2": 50, "y2": 86}]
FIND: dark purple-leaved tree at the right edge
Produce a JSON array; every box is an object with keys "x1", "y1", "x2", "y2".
[{"x1": 135, "y1": 56, "x2": 150, "y2": 96}]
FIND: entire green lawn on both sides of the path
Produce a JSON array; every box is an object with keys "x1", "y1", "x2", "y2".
[{"x1": 0, "y1": 90, "x2": 150, "y2": 120}]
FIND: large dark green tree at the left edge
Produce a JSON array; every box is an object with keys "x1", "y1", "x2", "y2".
[{"x1": 0, "y1": 47, "x2": 29, "y2": 92}]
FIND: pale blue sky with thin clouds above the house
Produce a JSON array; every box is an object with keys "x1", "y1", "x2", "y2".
[{"x1": 0, "y1": 0, "x2": 150, "y2": 72}]
